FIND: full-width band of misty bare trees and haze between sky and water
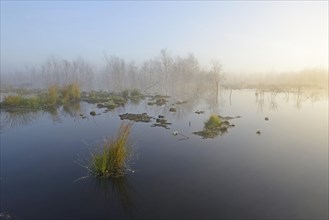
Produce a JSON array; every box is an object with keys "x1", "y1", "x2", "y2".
[{"x1": 0, "y1": 49, "x2": 328, "y2": 98}]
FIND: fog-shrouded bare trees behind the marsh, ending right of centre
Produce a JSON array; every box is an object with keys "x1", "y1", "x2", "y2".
[{"x1": 1, "y1": 49, "x2": 223, "y2": 99}]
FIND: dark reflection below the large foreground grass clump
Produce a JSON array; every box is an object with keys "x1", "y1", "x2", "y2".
[{"x1": 95, "y1": 176, "x2": 139, "y2": 214}]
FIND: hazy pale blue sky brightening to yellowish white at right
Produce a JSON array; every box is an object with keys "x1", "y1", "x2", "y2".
[{"x1": 1, "y1": 0, "x2": 329, "y2": 73}]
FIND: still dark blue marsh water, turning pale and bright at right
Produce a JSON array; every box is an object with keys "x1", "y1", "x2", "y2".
[{"x1": 0, "y1": 90, "x2": 328, "y2": 219}]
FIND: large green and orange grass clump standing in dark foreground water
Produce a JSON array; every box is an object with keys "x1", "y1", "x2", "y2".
[{"x1": 90, "y1": 123, "x2": 132, "y2": 177}]
